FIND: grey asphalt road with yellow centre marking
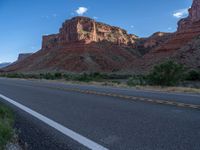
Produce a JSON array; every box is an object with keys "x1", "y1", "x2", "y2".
[{"x1": 0, "y1": 78, "x2": 200, "y2": 150}]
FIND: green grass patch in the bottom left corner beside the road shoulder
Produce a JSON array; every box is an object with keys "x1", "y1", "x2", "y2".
[{"x1": 0, "y1": 103, "x2": 14, "y2": 150}]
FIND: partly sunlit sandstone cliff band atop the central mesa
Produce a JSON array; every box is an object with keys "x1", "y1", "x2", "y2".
[{"x1": 42, "y1": 17, "x2": 138, "y2": 49}]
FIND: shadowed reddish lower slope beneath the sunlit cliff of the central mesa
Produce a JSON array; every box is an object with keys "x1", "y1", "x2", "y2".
[{"x1": 5, "y1": 42, "x2": 137, "y2": 72}]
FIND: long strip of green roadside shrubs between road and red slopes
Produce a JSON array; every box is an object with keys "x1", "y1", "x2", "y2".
[{"x1": 0, "y1": 60, "x2": 200, "y2": 90}]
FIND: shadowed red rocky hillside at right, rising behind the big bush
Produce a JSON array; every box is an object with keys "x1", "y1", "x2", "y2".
[{"x1": 135, "y1": 0, "x2": 200, "y2": 71}]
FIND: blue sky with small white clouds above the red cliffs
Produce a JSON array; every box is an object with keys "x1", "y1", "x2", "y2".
[{"x1": 0, "y1": 0, "x2": 192, "y2": 62}]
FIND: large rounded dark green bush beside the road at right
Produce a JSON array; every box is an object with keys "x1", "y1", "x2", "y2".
[{"x1": 147, "y1": 60, "x2": 184, "y2": 86}]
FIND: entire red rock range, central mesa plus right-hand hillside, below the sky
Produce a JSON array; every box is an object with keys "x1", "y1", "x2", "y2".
[{"x1": 5, "y1": 0, "x2": 200, "y2": 73}]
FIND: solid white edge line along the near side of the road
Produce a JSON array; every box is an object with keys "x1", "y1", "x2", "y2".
[{"x1": 0, "y1": 94, "x2": 108, "y2": 150}]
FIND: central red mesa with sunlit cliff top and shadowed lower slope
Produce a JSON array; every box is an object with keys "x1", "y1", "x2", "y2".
[{"x1": 3, "y1": 17, "x2": 141, "y2": 72}]
